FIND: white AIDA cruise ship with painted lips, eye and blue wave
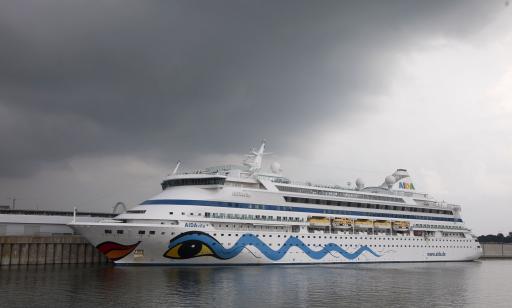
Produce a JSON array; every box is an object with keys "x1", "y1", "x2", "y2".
[{"x1": 69, "y1": 142, "x2": 482, "y2": 265}]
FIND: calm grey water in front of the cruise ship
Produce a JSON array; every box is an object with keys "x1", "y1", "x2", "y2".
[{"x1": 0, "y1": 260, "x2": 512, "y2": 308}]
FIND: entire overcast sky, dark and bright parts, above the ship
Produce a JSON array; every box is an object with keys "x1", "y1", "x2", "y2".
[{"x1": 0, "y1": 0, "x2": 512, "y2": 234}]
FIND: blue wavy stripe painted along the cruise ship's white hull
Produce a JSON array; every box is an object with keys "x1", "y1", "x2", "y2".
[{"x1": 164, "y1": 231, "x2": 381, "y2": 261}]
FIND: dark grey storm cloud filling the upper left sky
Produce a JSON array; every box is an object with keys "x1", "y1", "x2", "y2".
[{"x1": 0, "y1": 0, "x2": 501, "y2": 177}]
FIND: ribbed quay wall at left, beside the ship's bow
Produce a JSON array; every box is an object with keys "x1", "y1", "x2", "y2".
[{"x1": 0, "y1": 235, "x2": 109, "y2": 266}]
